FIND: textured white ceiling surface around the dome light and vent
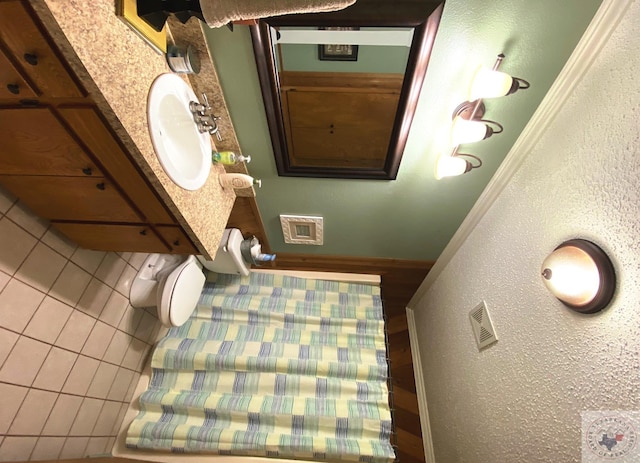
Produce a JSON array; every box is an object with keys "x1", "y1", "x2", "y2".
[{"x1": 414, "y1": 1, "x2": 640, "y2": 463}]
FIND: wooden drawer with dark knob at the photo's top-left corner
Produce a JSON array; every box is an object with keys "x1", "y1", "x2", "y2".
[{"x1": 0, "y1": 1, "x2": 85, "y2": 97}]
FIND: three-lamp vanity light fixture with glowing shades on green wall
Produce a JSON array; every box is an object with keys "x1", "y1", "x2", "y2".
[{"x1": 435, "y1": 53, "x2": 529, "y2": 180}]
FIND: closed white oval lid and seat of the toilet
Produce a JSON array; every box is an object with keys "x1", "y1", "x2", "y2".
[{"x1": 160, "y1": 259, "x2": 205, "y2": 326}]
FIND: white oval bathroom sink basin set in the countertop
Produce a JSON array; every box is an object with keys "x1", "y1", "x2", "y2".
[{"x1": 147, "y1": 74, "x2": 211, "y2": 190}]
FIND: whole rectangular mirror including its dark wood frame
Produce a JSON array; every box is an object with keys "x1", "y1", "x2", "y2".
[{"x1": 251, "y1": 0, "x2": 442, "y2": 180}]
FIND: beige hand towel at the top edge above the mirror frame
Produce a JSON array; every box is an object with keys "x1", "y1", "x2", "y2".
[{"x1": 200, "y1": 0, "x2": 356, "y2": 27}]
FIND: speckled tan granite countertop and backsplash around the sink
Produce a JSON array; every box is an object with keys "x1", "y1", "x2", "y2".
[{"x1": 30, "y1": 0, "x2": 245, "y2": 258}]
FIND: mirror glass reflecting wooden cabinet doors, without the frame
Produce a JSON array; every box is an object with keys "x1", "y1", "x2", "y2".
[{"x1": 278, "y1": 27, "x2": 413, "y2": 171}]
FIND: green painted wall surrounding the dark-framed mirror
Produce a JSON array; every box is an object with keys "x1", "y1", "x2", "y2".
[{"x1": 206, "y1": 0, "x2": 601, "y2": 259}]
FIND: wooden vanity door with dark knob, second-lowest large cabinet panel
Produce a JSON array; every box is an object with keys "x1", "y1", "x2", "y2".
[{"x1": 0, "y1": 175, "x2": 141, "y2": 223}]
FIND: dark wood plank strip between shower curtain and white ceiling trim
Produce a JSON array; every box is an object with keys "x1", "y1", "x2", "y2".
[{"x1": 381, "y1": 269, "x2": 428, "y2": 463}]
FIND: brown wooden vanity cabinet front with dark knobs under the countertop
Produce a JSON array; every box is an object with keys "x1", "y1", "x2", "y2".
[{"x1": 0, "y1": 0, "x2": 198, "y2": 254}]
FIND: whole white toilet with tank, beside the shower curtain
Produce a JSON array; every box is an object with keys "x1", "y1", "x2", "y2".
[{"x1": 129, "y1": 228, "x2": 249, "y2": 327}]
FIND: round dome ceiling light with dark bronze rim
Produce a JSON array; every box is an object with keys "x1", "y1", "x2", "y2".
[{"x1": 542, "y1": 239, "x2": 615, "y2": 313}]
